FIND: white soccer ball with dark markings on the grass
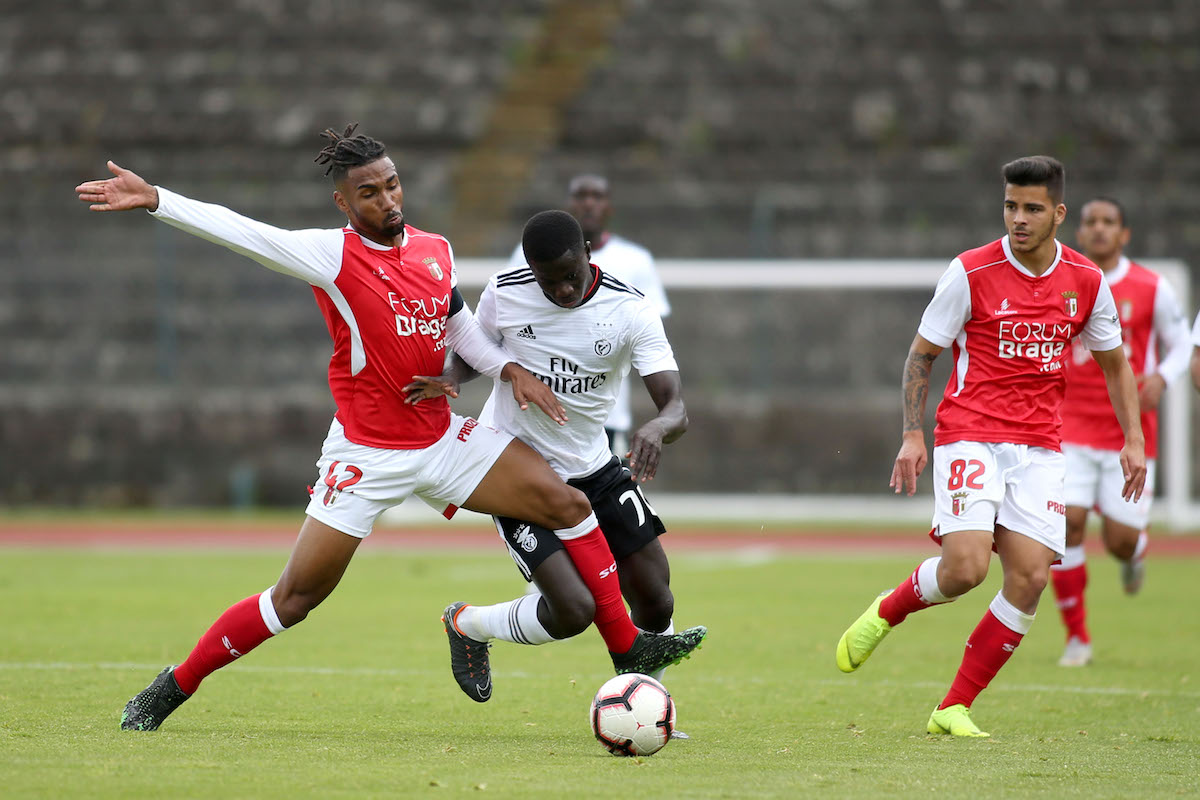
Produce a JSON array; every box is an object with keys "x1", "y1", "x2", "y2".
[{"x1": 592, "y1": 673, "x2": 674, "y2": 756}]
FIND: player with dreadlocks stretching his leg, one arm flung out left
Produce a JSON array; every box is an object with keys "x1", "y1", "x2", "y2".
[{"x1": 76, "y1": 126, "x2": 704, "y2": 730}]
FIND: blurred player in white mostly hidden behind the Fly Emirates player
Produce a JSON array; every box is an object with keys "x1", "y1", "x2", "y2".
[{"x1": 509, "y1": 174, "x2": 671, "y2": 458}]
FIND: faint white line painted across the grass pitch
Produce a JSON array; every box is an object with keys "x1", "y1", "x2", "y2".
[{"x1": 0, "y1": 661, "x2": 1200, "y2": 698}]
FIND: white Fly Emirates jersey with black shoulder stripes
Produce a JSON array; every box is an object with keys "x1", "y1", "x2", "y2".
[{"x1": 475, "y1": 266, "x2": 679, "y2": 480}]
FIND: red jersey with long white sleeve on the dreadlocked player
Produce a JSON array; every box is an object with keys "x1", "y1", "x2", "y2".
[{"x1": 151, "y1": 186, "x2": 460, "y2": 450}]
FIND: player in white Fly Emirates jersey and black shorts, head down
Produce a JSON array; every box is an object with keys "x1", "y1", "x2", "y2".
[{"x1": 412, "y1": 211, "x2": 704, "y2": 724}]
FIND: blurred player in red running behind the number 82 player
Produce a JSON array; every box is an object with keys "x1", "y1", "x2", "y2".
[{"x1": 1050, "y1": 197, "x2": 1190, "y2": 667}]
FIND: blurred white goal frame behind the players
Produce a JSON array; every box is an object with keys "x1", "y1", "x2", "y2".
[{"x1": 388, "y1": 259, "x2": 1200, "y2": 530}]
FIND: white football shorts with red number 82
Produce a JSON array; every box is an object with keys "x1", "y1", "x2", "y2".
[{"x1": 934, "y1": 441, "x2": 1067, "y2": 557}]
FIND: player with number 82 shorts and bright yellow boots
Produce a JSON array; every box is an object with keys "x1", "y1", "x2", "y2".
[{"x1": 836, "y1": 156, "x2": 1146, "y2": 736}]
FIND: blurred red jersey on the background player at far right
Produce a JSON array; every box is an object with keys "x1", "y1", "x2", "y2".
[{"x1": 1062, "y1": 258, "x2": 1177, "y2": 458}]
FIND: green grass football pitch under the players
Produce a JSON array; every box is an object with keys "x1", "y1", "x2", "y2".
[{"x1": 0, "y1": 527, "x2": 1200, "y2": 799}]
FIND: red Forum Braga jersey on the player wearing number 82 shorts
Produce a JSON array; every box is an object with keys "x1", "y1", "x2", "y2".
[{"x1": 918, "y1": 236, "x2": 1121, "y2": 450}]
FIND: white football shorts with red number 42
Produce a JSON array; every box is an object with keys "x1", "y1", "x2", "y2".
[{"x1": 305, "y1": 414, "x2": 512, "y2": 539}]
